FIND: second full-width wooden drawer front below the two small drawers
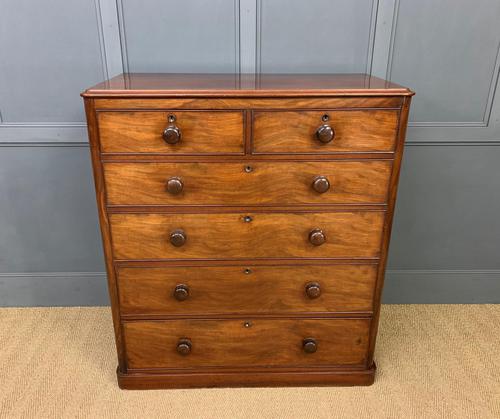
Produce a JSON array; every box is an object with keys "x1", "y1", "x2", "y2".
[{"x1": 110, "y1": 211, "x2": 384, "y2": 259}]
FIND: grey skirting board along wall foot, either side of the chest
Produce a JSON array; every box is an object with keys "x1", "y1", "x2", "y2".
[{"x1": 0, "y1": 269, "x2": 500, "y2": 307}]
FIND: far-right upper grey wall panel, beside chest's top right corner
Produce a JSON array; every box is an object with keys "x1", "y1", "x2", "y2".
[{"x1": 388, "y1": 0, "x2": 500, "y2": 126}]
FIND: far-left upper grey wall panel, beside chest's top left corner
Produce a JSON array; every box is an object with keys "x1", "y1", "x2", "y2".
[{"x1": 0, "y1": 0, "x2": 106, "y2": 124}]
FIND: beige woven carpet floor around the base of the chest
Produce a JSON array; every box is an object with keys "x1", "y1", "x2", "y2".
[{"x1": 0, "y1": 305, "x2": 500, "y2": 419}]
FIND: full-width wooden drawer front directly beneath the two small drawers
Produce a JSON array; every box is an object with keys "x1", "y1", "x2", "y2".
[{"x1": 104, "y1": 161, "x2": 392, "y2": 205}]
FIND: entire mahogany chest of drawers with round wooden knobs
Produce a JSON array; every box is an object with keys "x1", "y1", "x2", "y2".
[{"x1": 82, "y1": 74, "x2": 413, "y2": 389}]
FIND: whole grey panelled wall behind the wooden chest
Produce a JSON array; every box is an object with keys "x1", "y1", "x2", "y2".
[{"x1": 0, "y1": 0, "x2": 500, "y2": 306}]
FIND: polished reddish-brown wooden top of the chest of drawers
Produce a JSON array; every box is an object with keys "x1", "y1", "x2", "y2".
[{"x1": 82, "y1": 73, "x2": 414, "y2": 97}]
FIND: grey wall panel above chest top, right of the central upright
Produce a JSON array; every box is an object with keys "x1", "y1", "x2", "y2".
[{"x1": 256, "y1": 0, "x2": 377, "y2": 73}]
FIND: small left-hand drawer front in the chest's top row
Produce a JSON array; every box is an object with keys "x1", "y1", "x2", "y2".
[{"x1": 97, "y1": 111, "x2": 243, "y2": 155}]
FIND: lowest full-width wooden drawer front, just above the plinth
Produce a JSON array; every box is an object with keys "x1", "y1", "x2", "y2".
[{"x1": 123, "y1": 319, "x2": 370, "y2": 369}]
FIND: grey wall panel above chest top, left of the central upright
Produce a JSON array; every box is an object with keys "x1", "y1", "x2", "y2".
[{"x1": 118, "y1": 0, "x2": 239, "y2": 73}]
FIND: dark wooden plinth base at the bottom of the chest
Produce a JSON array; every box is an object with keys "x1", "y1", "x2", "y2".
[{"x1": 116, "y1": 364, "x2": 376, "y2": 390}]
